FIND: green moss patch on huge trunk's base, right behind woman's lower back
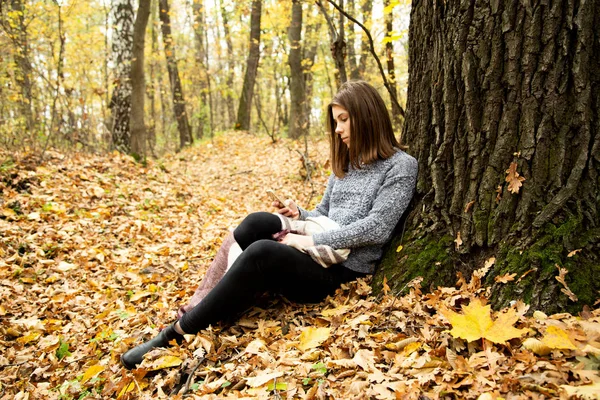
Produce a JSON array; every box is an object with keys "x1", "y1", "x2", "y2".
[{"x1": 373, "y1": 235, "x2": 453, "y2": 294}]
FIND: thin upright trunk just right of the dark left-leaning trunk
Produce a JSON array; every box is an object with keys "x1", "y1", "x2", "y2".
[{"x1": 193, "y1": 0, "x2": 209, "y2": 138}]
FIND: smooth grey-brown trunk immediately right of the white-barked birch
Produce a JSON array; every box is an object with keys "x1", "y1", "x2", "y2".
[{"x1": 130, "y1": 0, "x2": 151, "y2": 158}]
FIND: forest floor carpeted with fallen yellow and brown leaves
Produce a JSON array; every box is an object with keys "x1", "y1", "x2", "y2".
[{"x1": 0, "y1": 133, "x2": 600, "y2": 399}]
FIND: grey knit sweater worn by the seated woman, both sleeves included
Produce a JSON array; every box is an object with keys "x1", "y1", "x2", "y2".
[{"x1": 299, "y1": 150, "x2": 417, "y2": 274}]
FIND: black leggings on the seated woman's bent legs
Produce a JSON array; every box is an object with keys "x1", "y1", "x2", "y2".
[{"x1": 179, "y1": 212, "x2": 364, "y2": 334}]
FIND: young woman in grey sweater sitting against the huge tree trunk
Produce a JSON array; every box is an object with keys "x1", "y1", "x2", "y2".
[{"x1": 121, "y1": 81, "x2": 417, "y2": 368}]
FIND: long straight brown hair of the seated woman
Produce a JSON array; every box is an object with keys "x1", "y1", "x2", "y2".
[{"x1": 327, "y1": 81, "x2": 400, "y2": 178}]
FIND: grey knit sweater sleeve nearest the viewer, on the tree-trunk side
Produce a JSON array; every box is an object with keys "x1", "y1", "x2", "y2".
[{"x1": 313, "y1": 157, "x2": 418, "y2": 249}]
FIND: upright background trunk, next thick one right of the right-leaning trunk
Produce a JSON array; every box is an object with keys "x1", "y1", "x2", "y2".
[{"x1": 288, "y1": 0, "x2": 307, "y2": 139}]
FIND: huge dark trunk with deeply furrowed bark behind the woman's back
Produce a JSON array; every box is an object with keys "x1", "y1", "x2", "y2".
[{"x1": 376, "y1": 0, "x2": 600, "y2": 312}]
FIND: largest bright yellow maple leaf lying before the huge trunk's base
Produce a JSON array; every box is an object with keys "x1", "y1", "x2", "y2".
[{"x1": 442, "y1": 299, "x2": 527, "y2": 343}]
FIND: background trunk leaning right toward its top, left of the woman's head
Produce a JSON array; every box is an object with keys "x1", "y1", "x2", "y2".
[{"x1": 235, "y1": 0, "x2": 262, "y2": 131}]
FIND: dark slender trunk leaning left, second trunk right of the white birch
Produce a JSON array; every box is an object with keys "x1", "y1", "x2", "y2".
[{"x1": 158, "y1": 0, "x2": 194, "y2": 150}]
